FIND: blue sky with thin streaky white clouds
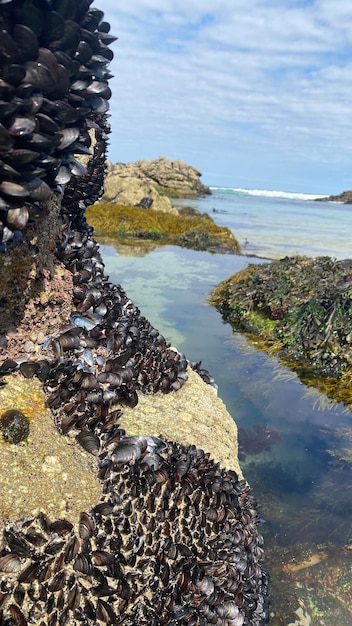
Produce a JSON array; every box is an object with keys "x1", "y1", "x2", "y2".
[{"x1": 100, "y1": 0, "x2": 352, "y2": 194}]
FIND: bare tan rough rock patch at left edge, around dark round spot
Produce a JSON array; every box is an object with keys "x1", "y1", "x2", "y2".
[{"x1": 0, "y1": 373, "x2": 101, "y2": 534}]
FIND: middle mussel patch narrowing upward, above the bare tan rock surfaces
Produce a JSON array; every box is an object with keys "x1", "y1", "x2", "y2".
[{"x1": 0, "y1": 213, "x2": 187, "y2": 436}]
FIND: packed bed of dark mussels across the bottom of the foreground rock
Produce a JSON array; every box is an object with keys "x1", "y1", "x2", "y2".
[{"x1": 0, "y1": 432, "x2": 266, "y2": 626}]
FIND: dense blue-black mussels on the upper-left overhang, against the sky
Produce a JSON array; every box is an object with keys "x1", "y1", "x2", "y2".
[{"x1": 0, "y1": 0, "x2": 116, "y2": 251}]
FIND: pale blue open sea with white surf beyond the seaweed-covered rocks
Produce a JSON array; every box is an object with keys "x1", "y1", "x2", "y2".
[{"x1": 174, "y1": 187, "x2": 352, "y2": 259}]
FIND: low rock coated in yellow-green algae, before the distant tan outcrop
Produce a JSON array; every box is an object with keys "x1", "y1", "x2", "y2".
[{"x1": 86, "y1": 197, "x2": 241, "y2": 254}]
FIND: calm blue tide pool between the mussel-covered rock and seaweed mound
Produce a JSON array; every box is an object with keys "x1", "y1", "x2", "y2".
[{"x1": 96, "y1": 197, "x2": 352, "y2": 626}]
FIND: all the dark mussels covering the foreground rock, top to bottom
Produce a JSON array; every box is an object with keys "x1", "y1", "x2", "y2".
[{"x1": 0, "y1": 0, "x2": 266, "y2": 626}]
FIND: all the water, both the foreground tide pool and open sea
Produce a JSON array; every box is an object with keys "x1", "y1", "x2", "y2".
[{"x1": 97, "y1": 189, "x2": 352, "y2": 626}]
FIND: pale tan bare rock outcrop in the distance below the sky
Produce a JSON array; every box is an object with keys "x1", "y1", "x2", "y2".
[{"x1": 103, "y1": 157, "x2": 211, "y2": 213}]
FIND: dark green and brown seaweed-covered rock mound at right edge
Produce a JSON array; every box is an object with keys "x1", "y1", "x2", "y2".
[{"x1": 211, "y1": 252, "x2": 352, "y2": 380}]
